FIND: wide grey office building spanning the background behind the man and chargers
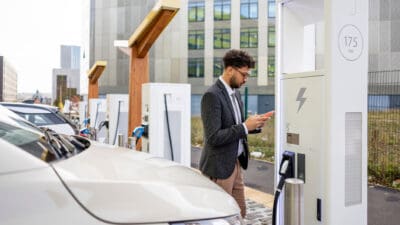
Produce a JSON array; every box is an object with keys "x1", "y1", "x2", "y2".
[{"x1": 88, "y1": 0, "x2": 400, "y2": 115}]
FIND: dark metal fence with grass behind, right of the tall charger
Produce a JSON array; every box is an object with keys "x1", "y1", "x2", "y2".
[{"x1": 368, "y1": 70, "x2": 400, "y2": 188}]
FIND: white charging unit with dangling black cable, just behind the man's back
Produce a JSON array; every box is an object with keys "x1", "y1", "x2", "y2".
[{"x1": 142, "y1": 83, "x2": 191, "y2": 166}]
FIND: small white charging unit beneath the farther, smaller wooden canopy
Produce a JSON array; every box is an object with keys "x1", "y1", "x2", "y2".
[{"x1": 89, "y1": 98, "x2": 107, "y2": 143}]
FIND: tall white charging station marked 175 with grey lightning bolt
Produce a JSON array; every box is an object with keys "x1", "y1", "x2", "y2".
[{"x1": 275, "y1": 0, "x2": 369, "y2": 225}]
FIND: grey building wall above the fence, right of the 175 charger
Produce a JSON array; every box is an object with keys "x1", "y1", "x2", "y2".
[{"x1": 368, "y1": 0, "x2": 400, "y2": 110}]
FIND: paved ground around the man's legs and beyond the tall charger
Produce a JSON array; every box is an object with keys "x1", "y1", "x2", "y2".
[{"x1": 192, "y1": 147, "x2": 400, "y2": 225}]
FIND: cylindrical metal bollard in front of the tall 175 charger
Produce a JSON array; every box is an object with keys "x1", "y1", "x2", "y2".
[{"x1": 284, "y1": 178, "x2": 304, "y2": 225}]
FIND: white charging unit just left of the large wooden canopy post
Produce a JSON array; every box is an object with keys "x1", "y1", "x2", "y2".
[{"x1": 106, "y1": 94, "x2": 129, "y2": 146}]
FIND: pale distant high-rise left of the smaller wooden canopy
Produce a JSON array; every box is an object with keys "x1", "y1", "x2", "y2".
[{"x1": 52, "y1": 45, "x2": 80, "y2": 103}]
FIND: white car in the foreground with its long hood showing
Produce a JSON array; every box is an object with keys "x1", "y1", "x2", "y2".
[{"x1": 0, "y1": 106, "x2": 244, "y2": 225}]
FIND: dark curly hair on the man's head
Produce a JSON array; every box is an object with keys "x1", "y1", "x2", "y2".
[{"x1": 223, "y1": 49, "x2": 255, "y2": 69}]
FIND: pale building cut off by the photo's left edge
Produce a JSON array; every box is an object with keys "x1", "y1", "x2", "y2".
[{"x1": 0, "y1": 56, "x2": 17, "y2": 102}]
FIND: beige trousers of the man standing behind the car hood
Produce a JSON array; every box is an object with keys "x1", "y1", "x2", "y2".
[{"x1": 210, "y1": 160, "x2": 246, "y2": 218}]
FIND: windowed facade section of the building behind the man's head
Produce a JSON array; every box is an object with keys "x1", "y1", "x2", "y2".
[{"x1": 187, "y1": 0, "x2": 275, "y2": 115}]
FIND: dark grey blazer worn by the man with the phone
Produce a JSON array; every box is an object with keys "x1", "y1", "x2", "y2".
[{"x1": 200, "y1": 79, "x2": 249, "y2": 179}]
